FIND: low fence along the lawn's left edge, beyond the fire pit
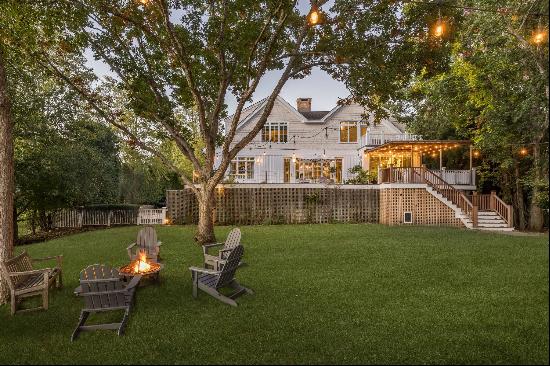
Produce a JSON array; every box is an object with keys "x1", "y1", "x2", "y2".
[{"x1": 52, "y1": 208, "x2": 166, "y2": 228}]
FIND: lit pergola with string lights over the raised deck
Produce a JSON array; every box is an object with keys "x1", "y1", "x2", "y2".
[{"x1": 364, "y1": 140, "x2": 473, "y2": 170}]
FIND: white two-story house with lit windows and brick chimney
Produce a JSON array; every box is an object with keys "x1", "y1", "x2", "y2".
[{"x1": 218, "y1": 97, "x2": 418, "y2": 183}]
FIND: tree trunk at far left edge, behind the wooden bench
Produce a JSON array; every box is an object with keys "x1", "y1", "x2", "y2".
[{"x1": 0, "y1": 45, "x2": 14, "y2": 304}]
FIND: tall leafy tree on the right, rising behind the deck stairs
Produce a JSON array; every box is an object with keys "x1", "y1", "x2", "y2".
[{"x1": 386, "y1": 0, "x2": 549, "y2": 230}]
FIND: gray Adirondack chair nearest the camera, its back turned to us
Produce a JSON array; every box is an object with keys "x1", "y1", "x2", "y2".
[{"x1": 71, "y1": 264, "x2": 141, "y2": 341}]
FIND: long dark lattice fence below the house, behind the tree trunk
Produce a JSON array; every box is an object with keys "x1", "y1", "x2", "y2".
[{"x1": 166, "y1": 184, "x2": 379, "y2": 225}]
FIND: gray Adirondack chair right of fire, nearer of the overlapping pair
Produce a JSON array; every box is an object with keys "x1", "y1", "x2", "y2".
[{"x1": 189, "y1": 245, "x2": 254, "y2": 306}]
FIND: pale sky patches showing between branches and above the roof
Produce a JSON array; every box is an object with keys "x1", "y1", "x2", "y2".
[{"x1": 86, "y1": 0, "x2": 349, "y2": 115}]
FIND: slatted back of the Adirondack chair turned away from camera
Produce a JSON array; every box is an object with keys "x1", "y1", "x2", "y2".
[{"x1": 80, "y1": 264, "x2": 126, "y2": 309}]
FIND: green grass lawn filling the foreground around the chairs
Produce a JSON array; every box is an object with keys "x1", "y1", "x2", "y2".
[{"x1": 0, "y1": 224, "x2": 549, "y2": 364}]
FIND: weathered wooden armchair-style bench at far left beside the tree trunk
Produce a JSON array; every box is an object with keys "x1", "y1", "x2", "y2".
[{"x1": 0, "y1": 251, "x2": 63, "y2": 315}]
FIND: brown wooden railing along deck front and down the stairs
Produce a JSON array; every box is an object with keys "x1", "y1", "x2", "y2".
[{"x1": 378, "y1": 167, "x2": 514, "y2": 227}]
